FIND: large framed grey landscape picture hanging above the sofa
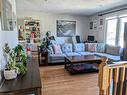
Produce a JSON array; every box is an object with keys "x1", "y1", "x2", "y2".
[{"x1": 56, "y1": 20, "x2": 76, "y2": 37}]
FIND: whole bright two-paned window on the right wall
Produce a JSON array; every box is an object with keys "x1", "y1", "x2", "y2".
[{"x1": 106, "y1": 16, "x2": 127, "y2": 47}]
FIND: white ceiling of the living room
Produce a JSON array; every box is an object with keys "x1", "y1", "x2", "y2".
[{"x1": 16, "y1": 0, "x2": 127, "y2": 15}]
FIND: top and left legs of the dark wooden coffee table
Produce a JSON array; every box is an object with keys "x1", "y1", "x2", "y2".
[{"x1": 64, "y1": 55, "x2": 101, "y2": 74}]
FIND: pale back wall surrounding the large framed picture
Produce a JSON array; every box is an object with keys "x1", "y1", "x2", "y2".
[{"x1": 17, "y1": 11, "x2": 89, "y2": 42}]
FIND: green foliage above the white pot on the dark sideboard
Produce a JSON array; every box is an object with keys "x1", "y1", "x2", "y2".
[{"x1": 3, "y1": 44, "x2": 27, "y2": 75}]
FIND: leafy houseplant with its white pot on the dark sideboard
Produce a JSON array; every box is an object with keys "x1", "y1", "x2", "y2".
[{"x1": 3, "y1": 44, "x2": 27, "y2": 80}]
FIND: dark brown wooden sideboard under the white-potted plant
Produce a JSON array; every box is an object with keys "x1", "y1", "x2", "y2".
[{"x1": 0, "y1": 59, "x2": 41, "y2": 95}]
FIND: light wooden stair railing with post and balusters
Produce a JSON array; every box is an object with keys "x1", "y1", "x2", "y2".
[{"x1": 98, "y1": 57, "x2": 127, "y2": 95}]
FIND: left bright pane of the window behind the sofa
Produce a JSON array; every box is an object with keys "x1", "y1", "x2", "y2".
[{"x1": 106, "y1": 18, "x2": 117, "y2": 45}]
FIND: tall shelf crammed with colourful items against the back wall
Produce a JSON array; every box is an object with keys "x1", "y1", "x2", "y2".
[{"x1": 19, "y1": 19, "x2": 41, "y2": 50}]
